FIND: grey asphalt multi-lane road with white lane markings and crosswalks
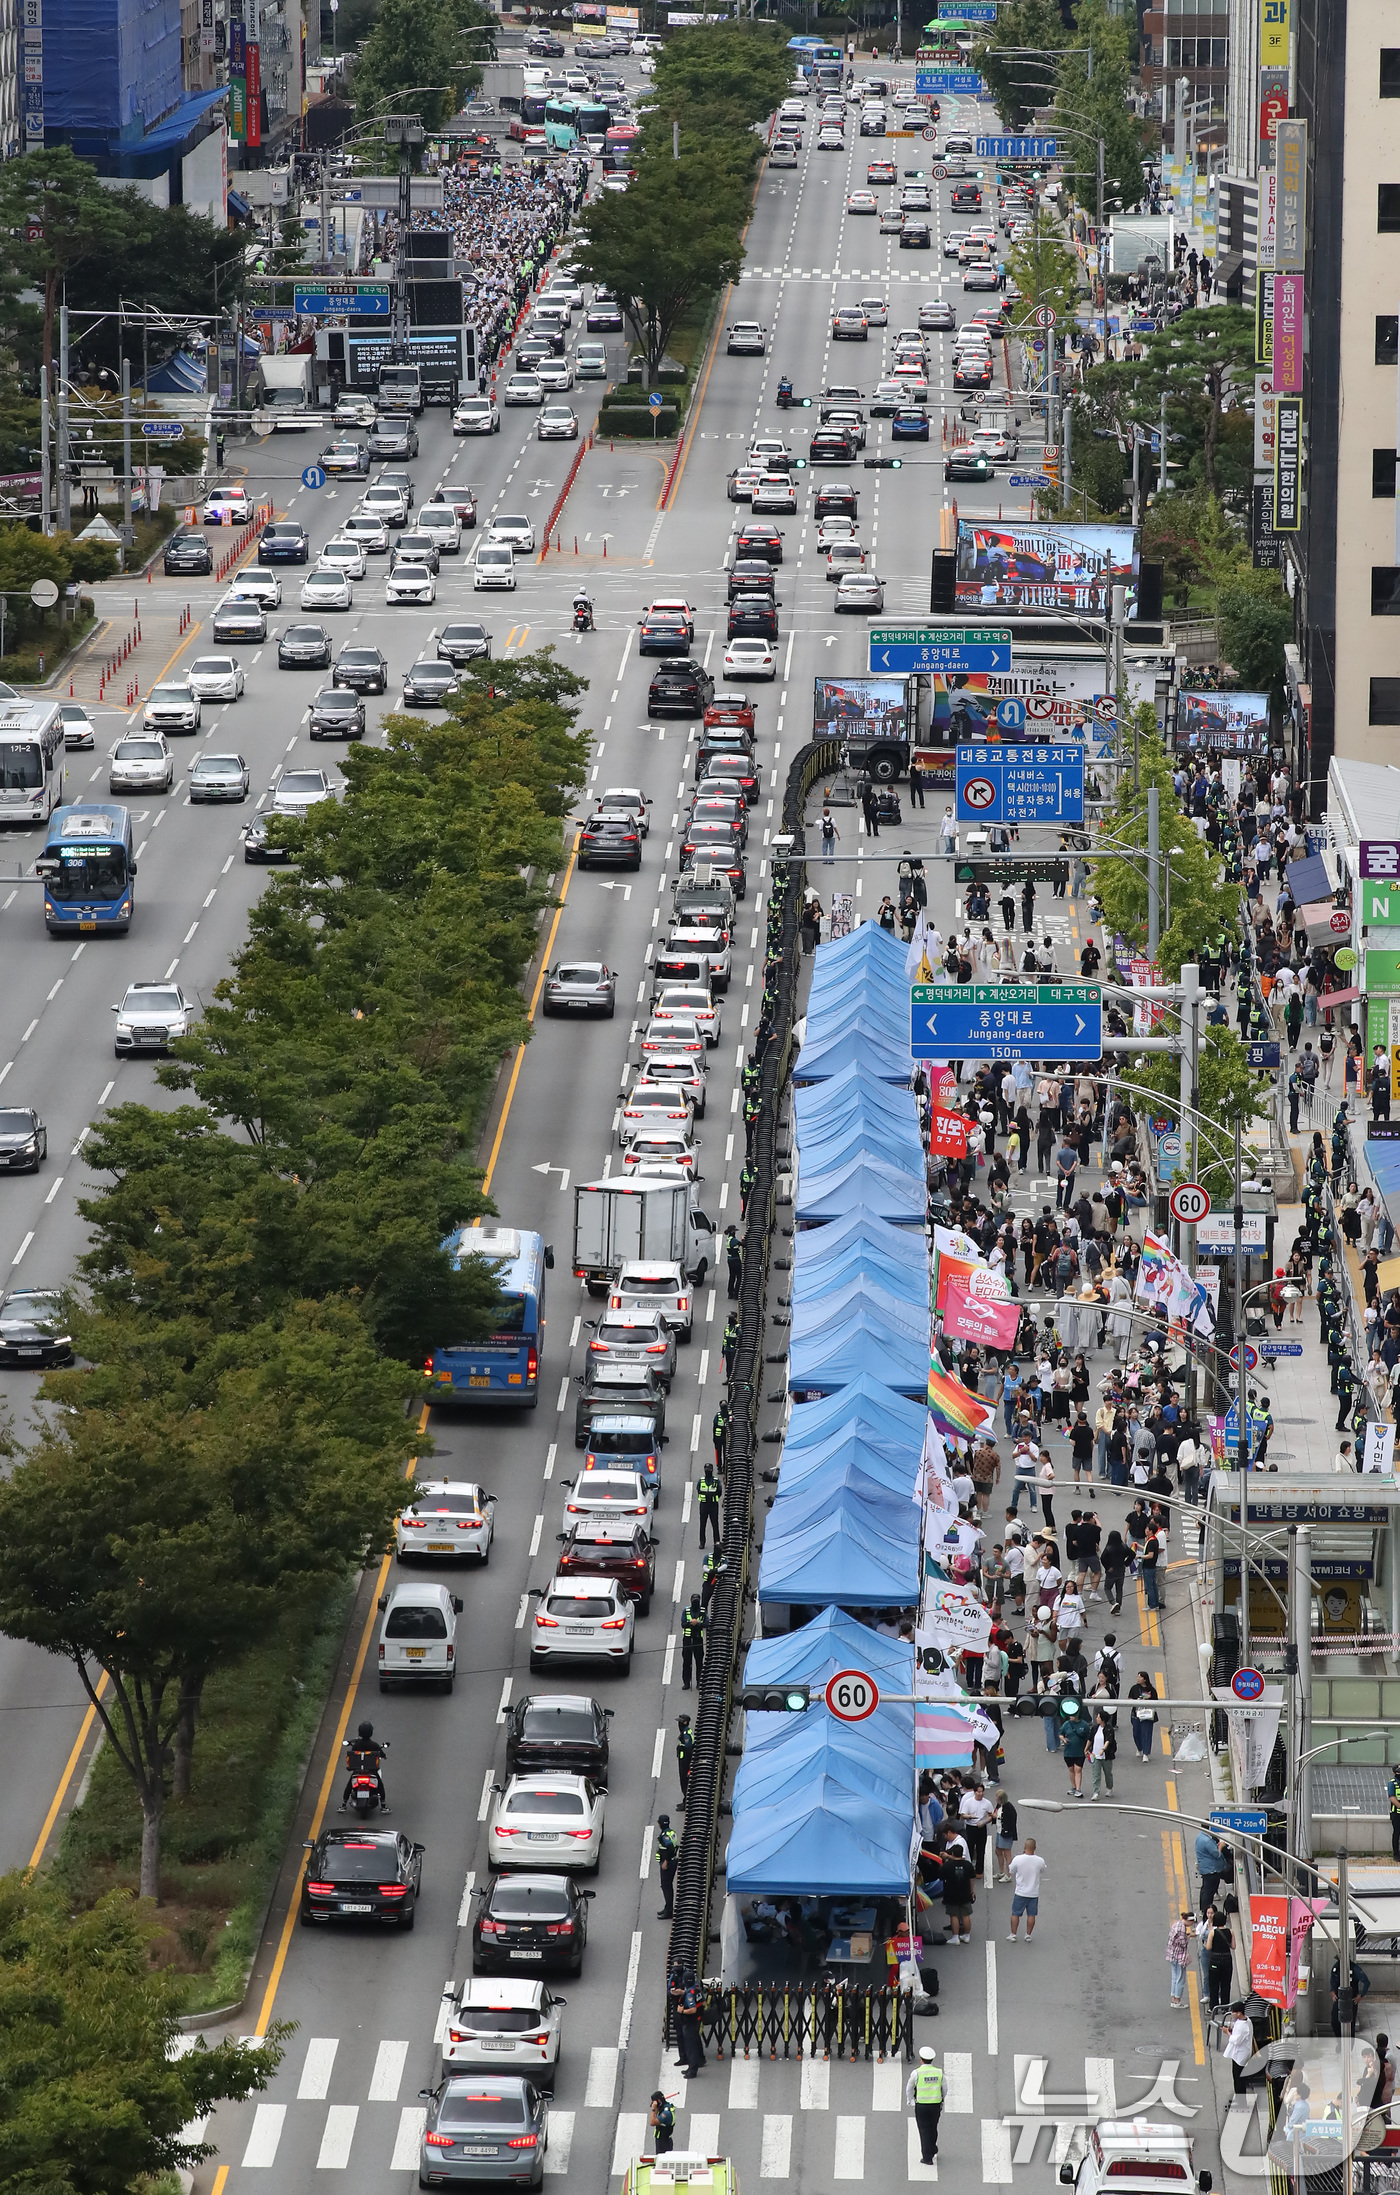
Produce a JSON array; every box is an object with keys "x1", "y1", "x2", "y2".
[{"x1": 0, "y1": 77, "x2": 1207, "y2": 2195}]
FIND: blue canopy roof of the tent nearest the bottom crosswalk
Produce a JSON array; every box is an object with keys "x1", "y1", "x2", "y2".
[{"x1": 724, "y1": 1776, "x2": 915, "y2": 1899}]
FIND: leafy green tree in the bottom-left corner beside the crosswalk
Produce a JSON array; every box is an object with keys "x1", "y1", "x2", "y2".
[{"x1": 0, "y1": 1872, "x2": 290, "y2": 2195}]
